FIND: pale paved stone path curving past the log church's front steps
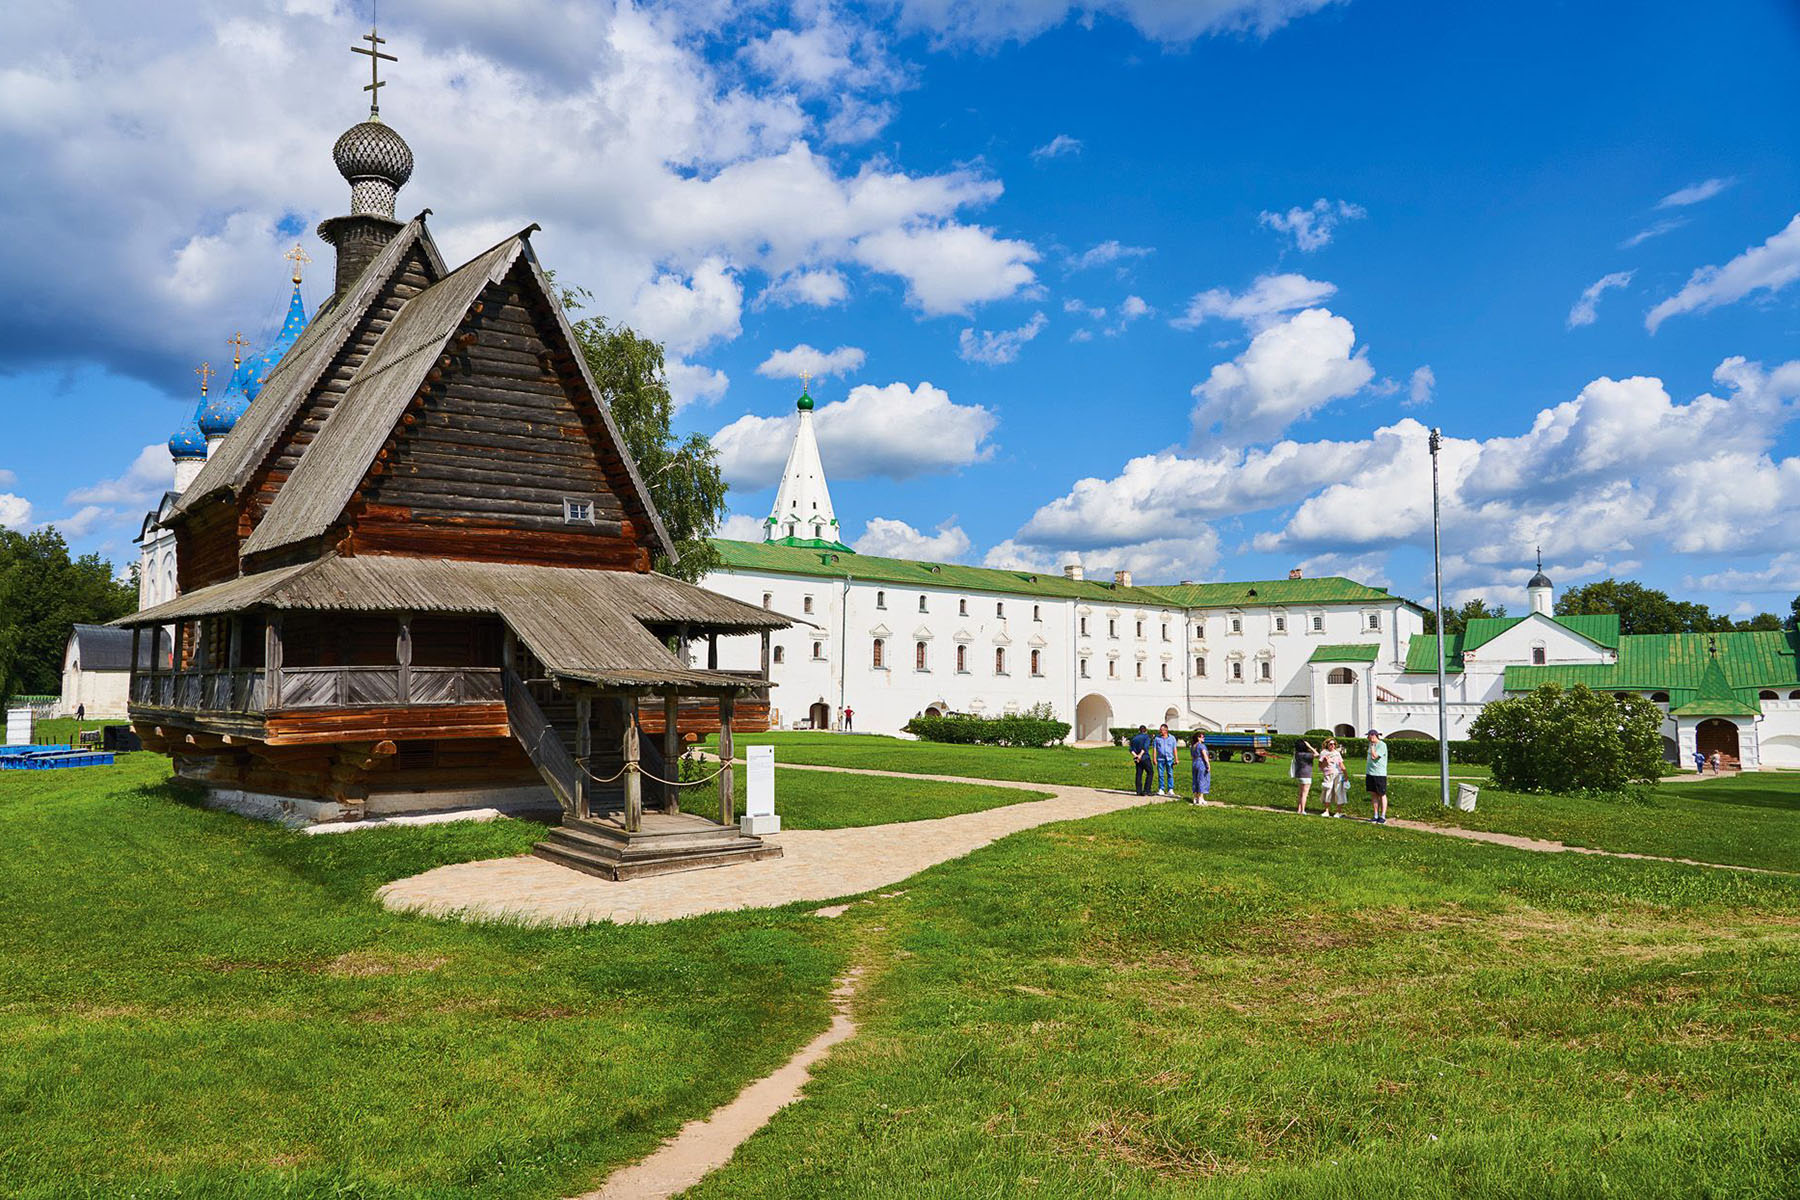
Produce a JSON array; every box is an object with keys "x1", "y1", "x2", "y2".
[{"x1": 376, "y1": 780, "x2": 1156, "y2": 925}]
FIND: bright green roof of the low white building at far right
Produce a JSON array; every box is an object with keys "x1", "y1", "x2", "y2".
[{"x1": 1507, "y1": 630, "x2": 1800, "y2": 716}]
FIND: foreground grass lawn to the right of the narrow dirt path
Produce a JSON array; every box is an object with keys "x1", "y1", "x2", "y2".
[{"x1": 689, "y1": 804, "x2": 1800, "y2": 1200}]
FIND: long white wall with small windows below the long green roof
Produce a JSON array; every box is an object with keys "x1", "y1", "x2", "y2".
[{"x1": 704, "y1": 570, "x2": 1420, "y2": 738}]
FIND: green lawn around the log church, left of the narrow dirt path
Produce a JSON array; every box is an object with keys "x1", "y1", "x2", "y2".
[{"x1": 0, "y1": 754, "x2": 846, "y2": 1200}]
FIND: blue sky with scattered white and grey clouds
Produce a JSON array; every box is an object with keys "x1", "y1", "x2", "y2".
[{"x1": 0, "y1": 0, "x2": 1800, "y2": 612}]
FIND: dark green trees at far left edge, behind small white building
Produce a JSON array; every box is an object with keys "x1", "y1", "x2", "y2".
[{"x1": 0, "y1": 527, "x2": 137, "y2": 696}]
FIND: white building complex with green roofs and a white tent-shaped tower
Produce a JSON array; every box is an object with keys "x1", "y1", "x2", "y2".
[{"x1": 706, "y1": 394, "x2": 1800, "y2": 768}]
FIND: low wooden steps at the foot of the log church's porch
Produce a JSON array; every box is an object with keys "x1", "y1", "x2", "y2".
[{"x1": 531, "y1": 813, "x2": 781, "y2": 880}]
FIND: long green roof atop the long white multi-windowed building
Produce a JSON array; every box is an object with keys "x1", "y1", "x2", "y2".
[{"x1": 713, "y1": 538, "x2": 1411, "y2": 608}]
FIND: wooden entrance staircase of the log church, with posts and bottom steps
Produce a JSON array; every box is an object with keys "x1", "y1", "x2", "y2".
[{"x1": 502, "y1": 671, "x2": 781, "y2": 880}]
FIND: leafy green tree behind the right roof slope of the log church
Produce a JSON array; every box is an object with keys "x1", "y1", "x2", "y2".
[{"x1": 558, "y1": 288, "x2": 727, "y2": 583}]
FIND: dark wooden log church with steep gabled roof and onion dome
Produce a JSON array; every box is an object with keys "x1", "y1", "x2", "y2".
[{"x1": 117, "y1": 32, "x2": 787, "y2": 878}]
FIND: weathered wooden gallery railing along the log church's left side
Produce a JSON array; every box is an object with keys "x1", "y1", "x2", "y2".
[{"x1": 131, "y1": 666, "x2": 502, "y2": 712}]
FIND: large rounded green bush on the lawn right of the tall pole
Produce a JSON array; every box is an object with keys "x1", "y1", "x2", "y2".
[{"x1": 1469, "y1": 684, "x2": 1663, "y2": 792}]
